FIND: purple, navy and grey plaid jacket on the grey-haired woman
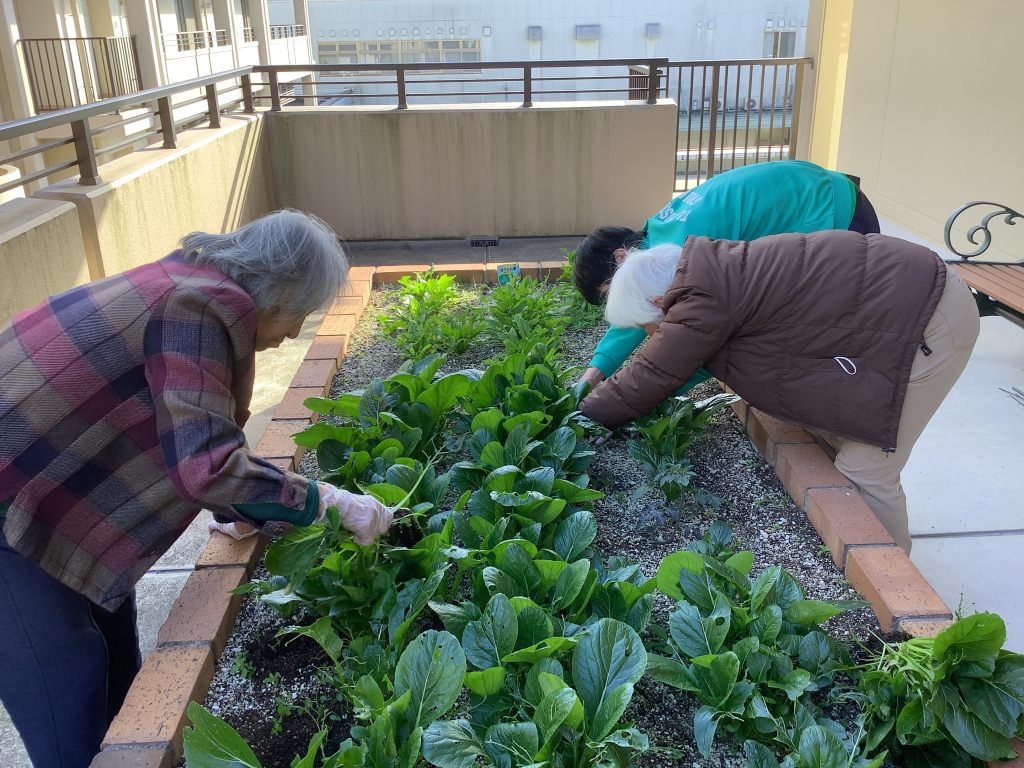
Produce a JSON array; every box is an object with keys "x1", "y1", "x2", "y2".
[{"x1": 0, "y1": 252, "x2": 318, "y2": 609}]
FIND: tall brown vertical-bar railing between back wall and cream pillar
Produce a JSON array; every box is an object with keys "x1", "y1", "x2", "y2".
[{"x1": 664, "y1": 58, "x2": 813, "y2": 190}]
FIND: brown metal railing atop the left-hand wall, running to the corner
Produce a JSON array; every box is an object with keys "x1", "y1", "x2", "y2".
[{"x1": 0, "y1": 67, "x2": 256, "y2": 194}]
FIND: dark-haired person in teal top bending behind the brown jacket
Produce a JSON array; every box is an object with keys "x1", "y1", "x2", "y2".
[{"x1": 572, "y1": 160, "x2": 879, "y2": 394}]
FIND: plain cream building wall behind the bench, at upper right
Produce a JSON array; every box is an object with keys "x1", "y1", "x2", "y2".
[{"x1": 831, "y1": 0, "x2": 1024, "y2": 258}]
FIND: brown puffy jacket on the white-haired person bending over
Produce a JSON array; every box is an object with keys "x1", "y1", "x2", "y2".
[{"x1": 581, "y1": 229, "x2": 946, "y2": 449}]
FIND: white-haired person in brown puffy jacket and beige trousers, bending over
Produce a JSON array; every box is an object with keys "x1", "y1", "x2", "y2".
[{"x1": 581, "y1": 230, "x2": 980, "y2": 552}]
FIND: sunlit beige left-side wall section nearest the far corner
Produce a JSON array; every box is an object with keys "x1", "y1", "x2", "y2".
[{"x1": 36, "y1": 117, "x2": 276, "y2": 279}]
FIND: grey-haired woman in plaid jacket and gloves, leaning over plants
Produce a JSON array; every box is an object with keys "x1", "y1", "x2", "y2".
[{"x1": 0, "y1": 211, "x2": 391, "y2": 768}]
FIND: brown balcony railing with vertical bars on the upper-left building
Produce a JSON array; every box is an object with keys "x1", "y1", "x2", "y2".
[{"x1": 17, "y1": 35, "x2": 142, "y2": 113}]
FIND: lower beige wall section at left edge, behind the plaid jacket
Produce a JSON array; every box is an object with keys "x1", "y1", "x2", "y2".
[{"x1": 0, "y1": 198, "x2": 89, "y2": 325}]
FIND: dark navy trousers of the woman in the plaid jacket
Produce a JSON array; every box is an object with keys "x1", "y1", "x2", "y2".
[{"x1": 0, "y1": 518, "x2": 141, "y2": 768}]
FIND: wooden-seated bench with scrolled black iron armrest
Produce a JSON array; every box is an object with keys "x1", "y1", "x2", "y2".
[{"x1": 945, "y1": 201, "x2": 1024, "y2": 328}]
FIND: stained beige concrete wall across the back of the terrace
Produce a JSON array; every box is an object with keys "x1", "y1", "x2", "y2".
[{"x1": 267, "y1": 100, "x2": 677, "y2": 240}]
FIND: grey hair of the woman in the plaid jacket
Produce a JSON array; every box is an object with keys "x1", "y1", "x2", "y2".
[{"x1": 181, "y1": 208, "x2": 348, "y2": 317}]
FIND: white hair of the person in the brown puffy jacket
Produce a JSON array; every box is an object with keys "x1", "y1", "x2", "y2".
[{"x1": 604, "y1": 243, "x2": 683, "y2": 328}]
